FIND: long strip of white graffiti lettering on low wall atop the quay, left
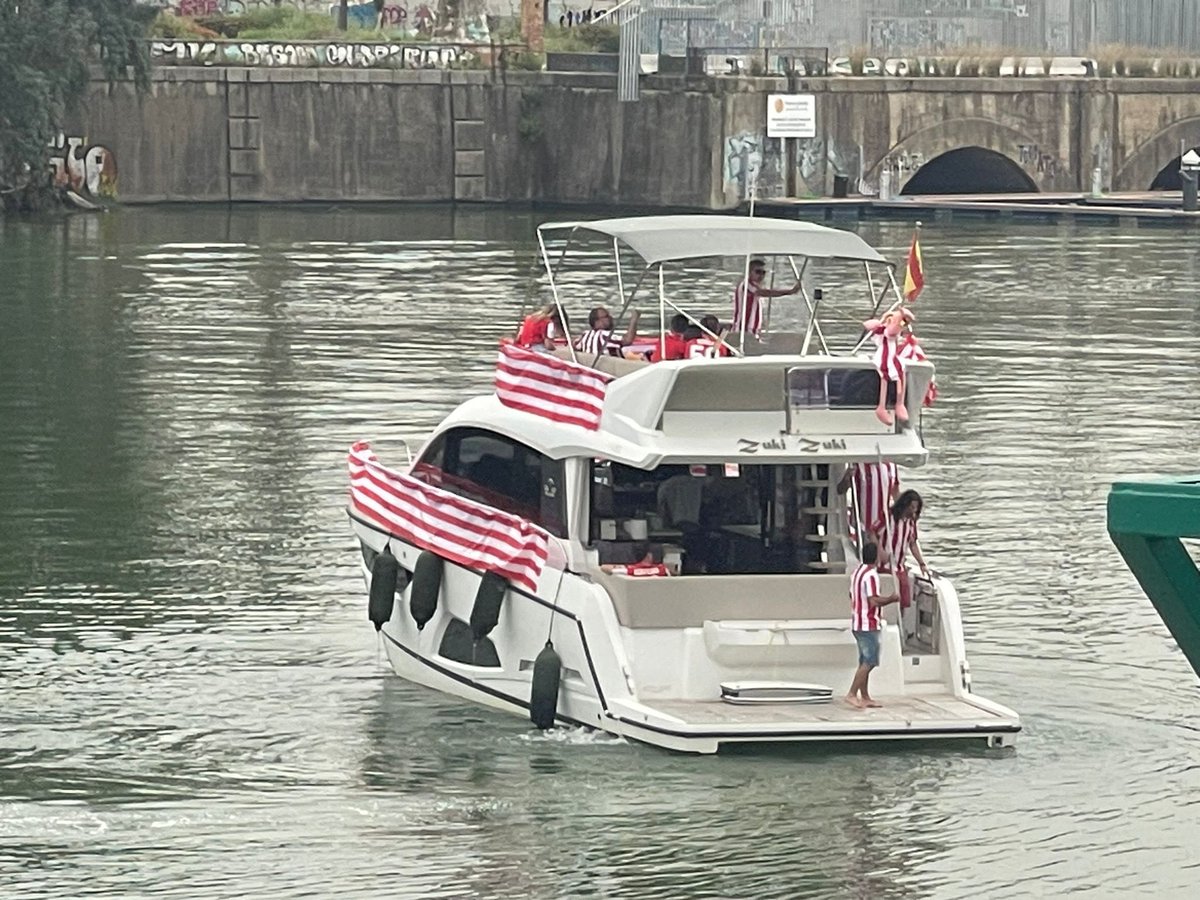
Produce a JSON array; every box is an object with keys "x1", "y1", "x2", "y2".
[{"x1": 150, "y1": 41, "x2": 463, "y2": 68}]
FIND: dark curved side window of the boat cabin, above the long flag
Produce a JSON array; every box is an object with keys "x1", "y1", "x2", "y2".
[{"x1": 412, "y1": 428, "x2": 566, "y2": 538}]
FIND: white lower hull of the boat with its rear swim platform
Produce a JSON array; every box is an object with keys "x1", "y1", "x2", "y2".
[{"x1": 355, "y1": 521, "x2": 1020, "y2": 754}]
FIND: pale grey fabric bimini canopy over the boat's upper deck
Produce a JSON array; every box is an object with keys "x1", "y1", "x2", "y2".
[{"x1": 539, "y1": 216, "x2": 887, "y2": 265}]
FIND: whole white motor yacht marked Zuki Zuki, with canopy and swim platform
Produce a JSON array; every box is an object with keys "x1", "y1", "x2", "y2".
[{"x1": 349, "y1": 216, "x2": 1020, "y2": 754}]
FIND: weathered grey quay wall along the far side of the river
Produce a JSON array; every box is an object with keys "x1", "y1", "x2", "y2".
[{"x1": 60, "y1": 65, "x2": 1200, "y2": 209}]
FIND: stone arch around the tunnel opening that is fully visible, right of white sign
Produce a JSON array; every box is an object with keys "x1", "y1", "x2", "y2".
[{"x1": 864, "y1": 118, "x2": 1075, "y2": 193}]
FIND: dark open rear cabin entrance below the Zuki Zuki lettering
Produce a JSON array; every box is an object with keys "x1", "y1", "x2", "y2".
[{"x1": 590, "y1": 460, "x2": 845, "y2": 575}]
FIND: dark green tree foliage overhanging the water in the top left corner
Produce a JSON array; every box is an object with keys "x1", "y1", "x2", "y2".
[{"x1": 0, "y1": 0, "x2": 156, "y2": 209}]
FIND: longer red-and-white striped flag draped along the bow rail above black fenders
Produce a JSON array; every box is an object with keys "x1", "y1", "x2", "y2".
[{"x1": 349, "y1": 440, "x2": 550, "y2": 590}]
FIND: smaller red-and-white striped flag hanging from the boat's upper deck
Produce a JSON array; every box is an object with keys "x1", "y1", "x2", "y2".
[{"x1": 496, "y1": 343, "x2": 612, "y2": 431}]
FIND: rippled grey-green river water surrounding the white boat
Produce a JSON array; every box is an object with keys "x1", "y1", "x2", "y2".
[{"x1": 0, "y1": 208, "x2": 1200, "y2": 898}]
